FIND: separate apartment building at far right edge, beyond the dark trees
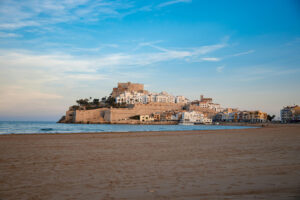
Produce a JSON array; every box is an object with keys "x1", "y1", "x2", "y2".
[{"x1": 280, "y1": 105, "x2": 300, "y2": 123}]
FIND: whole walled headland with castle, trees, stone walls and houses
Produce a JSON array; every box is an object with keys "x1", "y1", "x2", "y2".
[{"x1": 58, "y1": 82, "x2": 272, "y2": 124}]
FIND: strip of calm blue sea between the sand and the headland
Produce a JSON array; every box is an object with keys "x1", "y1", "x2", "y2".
[{"x1": 0, "y1": 121, "x2": 253, "y2": 134}]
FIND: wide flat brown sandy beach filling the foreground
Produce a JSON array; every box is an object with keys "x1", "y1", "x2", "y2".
[{"x1": 0, "y1": 125, "x2": 300, "y2": 200}]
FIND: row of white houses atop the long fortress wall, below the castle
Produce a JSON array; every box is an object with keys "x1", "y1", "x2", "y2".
[{"x1": 115, "y1": 91, "x2": 188, "y2": 104}]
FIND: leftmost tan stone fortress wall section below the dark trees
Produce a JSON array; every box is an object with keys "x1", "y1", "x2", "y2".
[{"x1": 75, "y1": 108, "x2": 107, "y2": 123}]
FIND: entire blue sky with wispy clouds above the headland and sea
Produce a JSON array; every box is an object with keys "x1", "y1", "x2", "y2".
[{"x1": 0, "y1": 0, "x2": 300, "y2": 121}]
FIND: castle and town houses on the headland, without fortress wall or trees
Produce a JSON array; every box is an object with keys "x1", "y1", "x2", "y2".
[{"x1": 112, "y1": 82, "x2": 267, "y2": 124}]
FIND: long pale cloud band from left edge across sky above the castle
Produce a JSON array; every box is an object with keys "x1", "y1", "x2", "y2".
[{"x1": 0, "y1": 39, "x2": 226, "y2": 72}]
